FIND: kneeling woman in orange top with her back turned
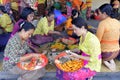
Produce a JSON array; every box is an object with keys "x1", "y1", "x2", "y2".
[{"x1": 96, "y1": 4, "x2": 120, "y2": 71}]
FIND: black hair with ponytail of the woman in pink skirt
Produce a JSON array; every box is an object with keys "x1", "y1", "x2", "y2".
[{"x1": 72, "y1": 17, "x2": 94, "y2": 33}]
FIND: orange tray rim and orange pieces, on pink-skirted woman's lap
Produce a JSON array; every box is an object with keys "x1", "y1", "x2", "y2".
[{"x1": 55, "y1": 52, "x2": 84, "y2": 72}]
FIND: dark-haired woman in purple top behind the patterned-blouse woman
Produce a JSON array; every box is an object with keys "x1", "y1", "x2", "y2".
[{"x1": 11, "y1": 7, "x2": 34, "y2": 36}]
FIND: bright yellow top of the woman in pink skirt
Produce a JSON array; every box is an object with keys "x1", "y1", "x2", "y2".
[{"x1": 79, "y1": 32, "x2": 101, "y2": 72}]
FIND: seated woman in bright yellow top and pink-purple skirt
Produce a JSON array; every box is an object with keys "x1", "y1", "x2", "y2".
[{"x1": 57, "y1": 17, "x2": 101, "y2": 80}]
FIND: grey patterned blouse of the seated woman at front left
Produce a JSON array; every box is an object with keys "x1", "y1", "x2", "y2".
[{"x1": 3, "y1": 33, "x2": 30, "y2": 71}]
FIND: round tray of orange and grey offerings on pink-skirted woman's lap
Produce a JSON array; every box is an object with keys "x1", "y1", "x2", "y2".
[{"x1": 55, "y1": 52, "x2": 84, "y2": 72}]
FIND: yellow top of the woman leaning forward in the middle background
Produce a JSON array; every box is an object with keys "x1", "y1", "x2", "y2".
[{"x1": 33, "y1": 17, "x2": 54, "y2": 35}]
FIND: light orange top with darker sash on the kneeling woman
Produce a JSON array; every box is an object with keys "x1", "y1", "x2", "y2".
[{"x1": 96, "y1": 17, "x2": 120, "y2": 52}]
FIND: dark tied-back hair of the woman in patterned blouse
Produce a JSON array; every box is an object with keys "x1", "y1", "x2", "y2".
[{"x1": 18, "y1": 21, "x2": 35, "y2": 32}]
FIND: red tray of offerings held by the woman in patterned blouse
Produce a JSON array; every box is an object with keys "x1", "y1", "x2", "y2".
[{"x1": 17, "y1": 54, "x2": 48, "y2": 70}]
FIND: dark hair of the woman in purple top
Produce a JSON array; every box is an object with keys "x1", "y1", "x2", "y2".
[{"x1": 20, "y1": 7, "x2": 34, "y2": 20}]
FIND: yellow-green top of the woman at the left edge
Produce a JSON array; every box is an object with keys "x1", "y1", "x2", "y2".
[{"x1": 0, "y1": 14, "x2": 13, "y2": 32}]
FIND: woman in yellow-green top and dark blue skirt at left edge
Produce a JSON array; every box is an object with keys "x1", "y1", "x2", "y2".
[{"x1": 0, "y1": 6, "x2": 13, "y2": 51}]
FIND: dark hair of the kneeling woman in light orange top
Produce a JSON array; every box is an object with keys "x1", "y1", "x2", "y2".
[{"x1": 99, "y1": 3, "x2": 113, "y2": 17}]
